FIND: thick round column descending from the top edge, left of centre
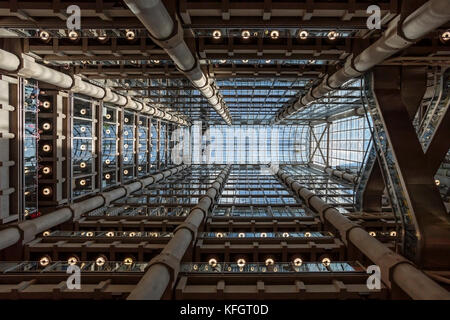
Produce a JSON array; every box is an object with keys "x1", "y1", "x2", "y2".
[{"x1": 125, "y1": 0, "x2": 231, "y2": 125}]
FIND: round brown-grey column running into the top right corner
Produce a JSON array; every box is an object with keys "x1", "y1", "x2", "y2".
[{"x1": 274, "y1": 0, "x2": 450, "y2": 123}]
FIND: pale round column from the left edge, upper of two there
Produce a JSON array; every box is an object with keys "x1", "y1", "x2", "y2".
[{"x1": 0, "y1": 49, "x2": 190, "y2": 126}]
